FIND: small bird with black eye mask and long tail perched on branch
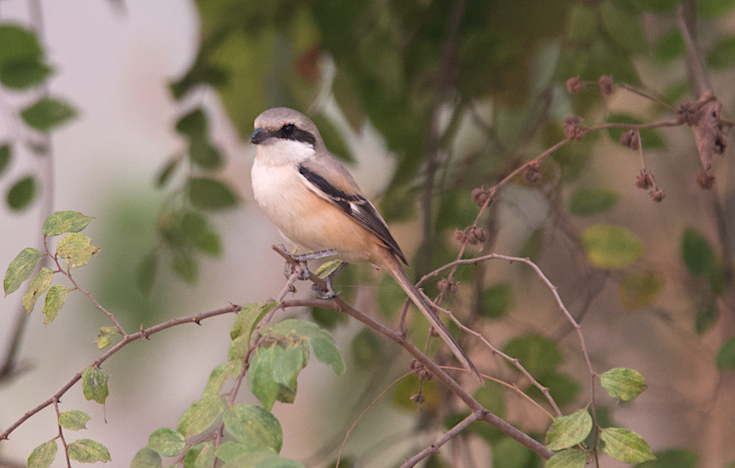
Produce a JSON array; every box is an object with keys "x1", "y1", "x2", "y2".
[{"x1": 250, "y1": 107, "x2": 483, "y2": 384}]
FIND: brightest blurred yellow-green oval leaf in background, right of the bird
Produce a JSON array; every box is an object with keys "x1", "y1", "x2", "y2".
[{"x1": 582, "y1": 224, "x2": 643, "y2": 269}]
